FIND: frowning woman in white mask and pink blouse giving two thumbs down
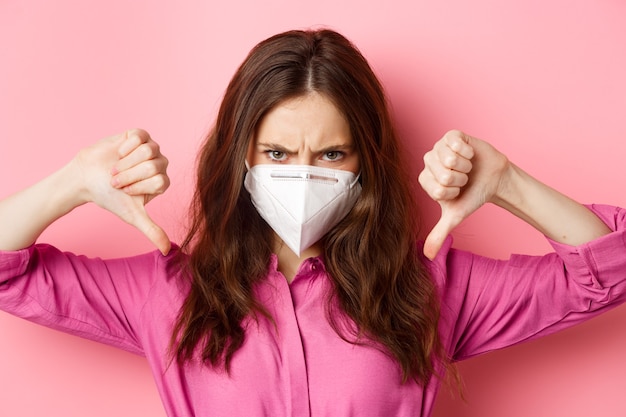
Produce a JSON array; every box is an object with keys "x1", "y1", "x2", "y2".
[{"x1": 0, "y1": 30, "x2": 626, "y2": 416}]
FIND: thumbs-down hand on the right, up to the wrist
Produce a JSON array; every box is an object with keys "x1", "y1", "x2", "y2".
[{"x1": 419, "y1": 130, "x2": 512, "y2": 259}]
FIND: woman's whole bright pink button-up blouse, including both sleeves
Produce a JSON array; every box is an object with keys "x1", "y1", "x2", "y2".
[{"x1": 0, "y1": 206, "x2": 626, "y2": 417}]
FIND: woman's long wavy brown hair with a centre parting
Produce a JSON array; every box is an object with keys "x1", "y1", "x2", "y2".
[{"x1": 172, "y1": 29, "x2": 445, "y2": 383}]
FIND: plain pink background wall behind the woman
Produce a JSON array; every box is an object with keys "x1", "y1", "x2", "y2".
[{"x1": 0, "y1": 0, "x2": 626, "y2": 417}]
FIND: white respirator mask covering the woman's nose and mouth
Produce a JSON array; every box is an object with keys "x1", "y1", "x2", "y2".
[{"x1": 244, "y1": 162, "x2": 361, "y2": 256}]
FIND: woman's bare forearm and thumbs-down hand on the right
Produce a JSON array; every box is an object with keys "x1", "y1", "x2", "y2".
[{"x1": 419, "y1": 131, "x2": 611, "y2": 259}]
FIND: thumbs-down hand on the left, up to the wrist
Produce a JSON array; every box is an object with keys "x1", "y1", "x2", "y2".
[{"x1": 71, "y1": 129, "x2": 170, "y2": 254}]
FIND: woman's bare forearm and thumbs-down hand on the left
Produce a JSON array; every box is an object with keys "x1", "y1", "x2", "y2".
[{"x1": 0, "y1": 130, "x2": 170, "y2": 254}]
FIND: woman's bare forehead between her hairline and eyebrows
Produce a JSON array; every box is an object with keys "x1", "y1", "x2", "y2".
[{"x1": 256, "y1": 92, "x2": 352, "y2": 147}]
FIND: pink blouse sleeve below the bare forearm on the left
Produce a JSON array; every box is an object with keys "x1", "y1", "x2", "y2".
[{"x1": 0, "y1": 245, "x2": 173, "y2": 354}]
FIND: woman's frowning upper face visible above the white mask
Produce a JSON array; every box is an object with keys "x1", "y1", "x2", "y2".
[{"x1": 246, "y1": 92, "x2": 360, "y2": 174}]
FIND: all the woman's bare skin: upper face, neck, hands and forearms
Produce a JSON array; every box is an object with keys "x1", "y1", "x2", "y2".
[{"x1": 0, "y1": 110, "x2": 610, "y2": 272}]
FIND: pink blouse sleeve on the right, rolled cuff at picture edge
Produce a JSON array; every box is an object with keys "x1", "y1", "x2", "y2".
[{"x1": 431, "y1": 205, "x2": 626, "y2": 360}]
